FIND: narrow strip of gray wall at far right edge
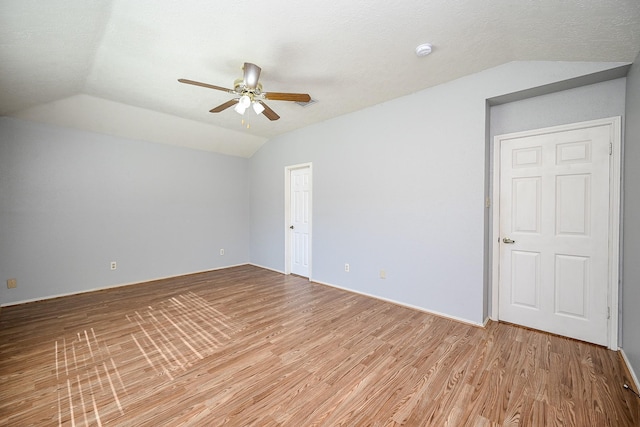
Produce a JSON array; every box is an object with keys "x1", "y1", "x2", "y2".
[{"x1": 621, "y1": 55, "x2": 640, "y2": 382}]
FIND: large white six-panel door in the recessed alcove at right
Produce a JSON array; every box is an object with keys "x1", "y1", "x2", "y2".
[{"x1": 496, "y1": 118, "x2": 616, "y2": 345}]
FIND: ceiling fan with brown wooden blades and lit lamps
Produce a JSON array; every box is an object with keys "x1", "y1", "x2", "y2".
[{"x1": 178, "y1": 62, "x2": 311, "y2": 120}]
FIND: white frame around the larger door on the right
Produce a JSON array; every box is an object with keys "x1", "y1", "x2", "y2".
[{"x1": 491, "y1": 116, "x2": 622, "y2": 351}]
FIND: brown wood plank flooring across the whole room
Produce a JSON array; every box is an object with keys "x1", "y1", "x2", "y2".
[{"x1": 0, "y1": 266, "x2": 640, "y2": 427}]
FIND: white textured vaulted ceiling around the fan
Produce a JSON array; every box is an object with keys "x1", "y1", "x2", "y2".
[{"x1": 0, "y1": 0, "x2": 640, "y2": 157}]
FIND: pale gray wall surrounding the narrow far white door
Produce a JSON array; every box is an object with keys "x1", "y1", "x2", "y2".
[{"x1": 250, "y1": 62, "x2": 620, "y2": 323}]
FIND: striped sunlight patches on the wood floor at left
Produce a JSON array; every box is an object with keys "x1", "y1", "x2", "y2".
[{"x1": 54, "y1": 292, "x2": 239, "y2": 425}]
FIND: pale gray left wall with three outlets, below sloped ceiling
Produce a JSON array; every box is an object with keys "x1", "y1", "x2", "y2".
[{"x1": 0, "y1": 118, "x2": 249, "y2": 304}]
